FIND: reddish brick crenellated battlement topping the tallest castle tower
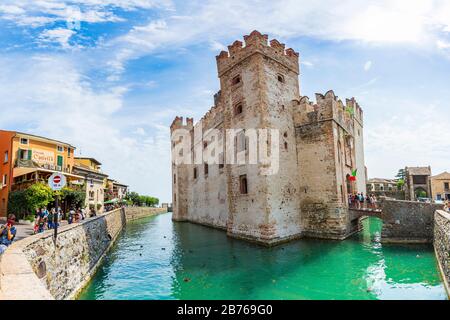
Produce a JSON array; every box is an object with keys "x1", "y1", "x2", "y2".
[{"x1": 216, "y1": 30, "x2": 299, "y2": 77}]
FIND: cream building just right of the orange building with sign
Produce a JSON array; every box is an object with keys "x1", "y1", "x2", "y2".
[{"x1": 73, "y1": 157, "x2": 108, "y2": 213}]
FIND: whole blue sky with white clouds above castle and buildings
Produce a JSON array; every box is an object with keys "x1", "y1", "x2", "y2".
[{"x1": 0, "y1": 0, "x2": 450, "y2": 202}]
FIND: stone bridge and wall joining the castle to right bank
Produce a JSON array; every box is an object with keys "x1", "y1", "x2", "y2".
[{"x1": 350, "y1": 199, "x2": 442, "y2": 243}]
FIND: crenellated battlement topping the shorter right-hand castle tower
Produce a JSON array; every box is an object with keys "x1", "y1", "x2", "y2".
[{"x1": 293, "y1": 90, "x2": 363, "y2": 132}]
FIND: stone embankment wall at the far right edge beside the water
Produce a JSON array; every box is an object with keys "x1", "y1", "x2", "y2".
[{"x1": 434, "y1": 210, "x2": 450, "y2": 299}]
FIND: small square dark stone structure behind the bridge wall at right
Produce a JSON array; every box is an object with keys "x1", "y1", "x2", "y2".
[{"x1": 405, "y1": 166, "x2": 431, "y2": 201}]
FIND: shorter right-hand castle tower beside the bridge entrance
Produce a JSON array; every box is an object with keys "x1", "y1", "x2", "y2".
[{"x1": 293, "y1": 90, "x2": 366, "y2": 239}]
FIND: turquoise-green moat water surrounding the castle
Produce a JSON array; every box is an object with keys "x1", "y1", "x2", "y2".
[{"x1": 80, "y1": 214, "x2": 446, "y2": 299}]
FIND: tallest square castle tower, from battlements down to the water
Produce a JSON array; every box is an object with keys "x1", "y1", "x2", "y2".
[{"x1": 216, "y1": 31, "x2": 301, "y2": 243}]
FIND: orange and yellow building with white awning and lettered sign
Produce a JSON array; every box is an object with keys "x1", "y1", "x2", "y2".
[{"x1": 0, "y1": 130, "x2": 83, "y2": 216}]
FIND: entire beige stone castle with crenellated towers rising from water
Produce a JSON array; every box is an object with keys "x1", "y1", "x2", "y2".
[{"x1": 171, "y1": 31, "x2": 366, "y2": 245}]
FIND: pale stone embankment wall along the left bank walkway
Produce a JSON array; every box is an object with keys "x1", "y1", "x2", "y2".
[{"x1": 0, "y1": 207, "x2": 167, "y2": 300}]
